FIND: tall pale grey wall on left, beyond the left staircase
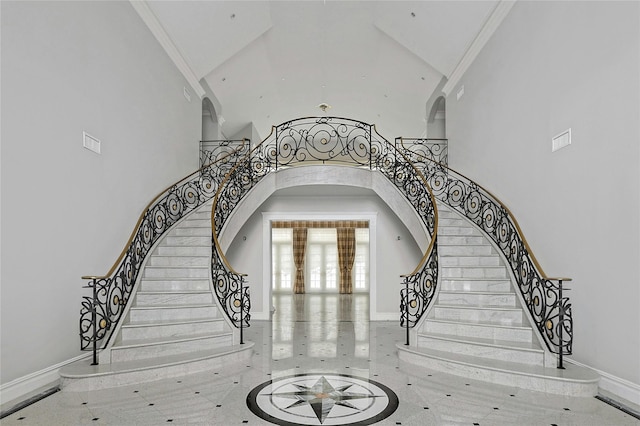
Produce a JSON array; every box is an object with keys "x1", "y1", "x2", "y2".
[{"x1": 0, "y1": 1, "x2": 201, "y2": 384}]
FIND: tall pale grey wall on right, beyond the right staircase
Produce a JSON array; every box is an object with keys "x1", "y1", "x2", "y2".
[{"x1": 447, "y1": 1, "x2": 640, "y2": 395}]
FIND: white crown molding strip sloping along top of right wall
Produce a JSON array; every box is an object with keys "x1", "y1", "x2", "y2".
[{"x1": 442, "y1": 0, "x2": 516, "y2": 97}]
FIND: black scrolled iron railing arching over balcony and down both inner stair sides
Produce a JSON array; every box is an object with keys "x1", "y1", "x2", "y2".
[{"x1": 211, "y1": 117, "x2": 438, "y2": 332}]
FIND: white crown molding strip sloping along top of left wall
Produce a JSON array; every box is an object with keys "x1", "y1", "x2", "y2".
[{"x1": 129, "y1": 0, "x2": 205, "y2": 99}]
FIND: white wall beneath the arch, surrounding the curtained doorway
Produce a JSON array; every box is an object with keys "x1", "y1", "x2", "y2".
[{"x1": 227, "y1": 190, "x2": 422, "y2": 319}]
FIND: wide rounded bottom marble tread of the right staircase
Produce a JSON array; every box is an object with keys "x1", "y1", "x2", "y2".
[{"x1": 396, "y1": 343, "x2": 600, "y2": 384}]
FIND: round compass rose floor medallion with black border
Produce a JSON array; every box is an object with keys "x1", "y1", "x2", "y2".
[{"x1": 247, "y1": 373, "x2": 398, "y2": 426}]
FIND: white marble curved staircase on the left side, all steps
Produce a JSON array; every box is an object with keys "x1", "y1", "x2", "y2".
[{"x1": 60, "y1": 202, "x2": 253, "y2": 390}]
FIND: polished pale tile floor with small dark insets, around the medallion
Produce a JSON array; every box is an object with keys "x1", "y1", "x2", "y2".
[{"x1": 0, "y1": 295, "x2": 640, "y2": 426}]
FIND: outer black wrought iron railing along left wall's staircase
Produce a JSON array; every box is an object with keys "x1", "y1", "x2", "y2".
[{"x1": 80, "y1": 140, "x2": 250, "y2": 356}]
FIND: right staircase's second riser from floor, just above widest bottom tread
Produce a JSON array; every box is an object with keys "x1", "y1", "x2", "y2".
[{"x1": 418, "y1": 335, "x2": 544, "y2": 366}]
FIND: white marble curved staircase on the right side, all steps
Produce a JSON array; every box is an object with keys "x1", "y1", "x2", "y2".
[{"x1": 398, "y1": 203, "x2": 599, "y2": 396}]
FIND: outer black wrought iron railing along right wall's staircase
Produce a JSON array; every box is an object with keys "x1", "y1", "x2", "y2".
[{"x1": 399, "y1": 140, "x2": 573, "y2": 358}]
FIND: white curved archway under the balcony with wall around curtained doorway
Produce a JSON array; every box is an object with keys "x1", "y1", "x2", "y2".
[{"x1": 220, "y1": 165, "x2": 429, "y2": 320}]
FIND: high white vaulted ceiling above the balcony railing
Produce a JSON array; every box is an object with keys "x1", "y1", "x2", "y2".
[{"x1": 147, "y1": 0, "x2": 499, "y2": 138}]
